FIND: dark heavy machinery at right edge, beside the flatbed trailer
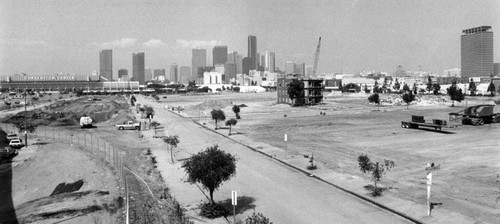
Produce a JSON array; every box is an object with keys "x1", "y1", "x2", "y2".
[{"x1": 449, "y1": 104, "x2": 500, "y2": 126}]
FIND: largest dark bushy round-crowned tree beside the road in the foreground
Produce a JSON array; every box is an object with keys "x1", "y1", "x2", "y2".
[{"x1": 182, "y1": 145, "x2": 236, "y2": 204}]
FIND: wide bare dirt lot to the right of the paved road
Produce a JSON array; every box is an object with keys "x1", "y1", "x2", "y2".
[{"x1": 161, "y1": 93, "x2": 500, "y2": 223}]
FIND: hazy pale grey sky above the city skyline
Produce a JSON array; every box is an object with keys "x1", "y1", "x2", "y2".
[{"x1": 0, "y1": 0, "x2": 500, "y2": 77}]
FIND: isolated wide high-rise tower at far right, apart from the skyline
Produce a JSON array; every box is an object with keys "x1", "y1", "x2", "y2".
[{"x1": 460, "y1": 26, "x2": 493, "y2": 78}]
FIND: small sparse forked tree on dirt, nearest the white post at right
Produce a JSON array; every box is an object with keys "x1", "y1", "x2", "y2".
[{"x1": 358, "y1": 154, "x2": 395, "y2": 196}]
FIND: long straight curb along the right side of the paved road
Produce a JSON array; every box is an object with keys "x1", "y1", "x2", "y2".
[{"x1": 163, "y1": 107, "x2": 423, "y2": 224}]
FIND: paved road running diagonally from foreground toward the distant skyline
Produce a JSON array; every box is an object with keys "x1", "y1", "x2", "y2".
[{"x1": 138, "y1": 97, "x2": 408, "y2": 223}]
